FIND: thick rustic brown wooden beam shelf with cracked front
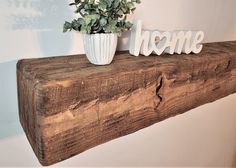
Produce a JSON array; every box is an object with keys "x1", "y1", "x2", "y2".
[{"x1": 17, "y1": 42, "x2": 236, "y2": 165}]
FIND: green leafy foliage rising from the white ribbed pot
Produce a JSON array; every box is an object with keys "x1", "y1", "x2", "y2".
[{"x1": 63, "y1": 0, "x2": 141, "y2": 34}]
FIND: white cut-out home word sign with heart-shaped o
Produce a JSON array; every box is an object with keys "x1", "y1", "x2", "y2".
[{"x1": 129, "y1": 20, "x2": 204, "y2": 56}]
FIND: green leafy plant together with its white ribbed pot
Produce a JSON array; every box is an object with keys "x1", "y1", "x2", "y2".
[{"x1": 63, "y1": 0, "x2": 140, "y2": 65}]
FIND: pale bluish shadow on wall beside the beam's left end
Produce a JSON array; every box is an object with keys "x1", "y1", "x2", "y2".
[{"x1": 0, "y1": 60, "x2": 22, "y2": 139}]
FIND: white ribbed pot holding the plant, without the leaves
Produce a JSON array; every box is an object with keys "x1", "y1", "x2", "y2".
[{"x1": 83, "y1": 33, "x2": 118, "y2": 65}]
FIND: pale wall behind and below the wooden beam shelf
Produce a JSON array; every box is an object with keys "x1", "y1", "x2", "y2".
[{"x1": 0, "y1": 0, "x2": 236, "y2": 166}]
